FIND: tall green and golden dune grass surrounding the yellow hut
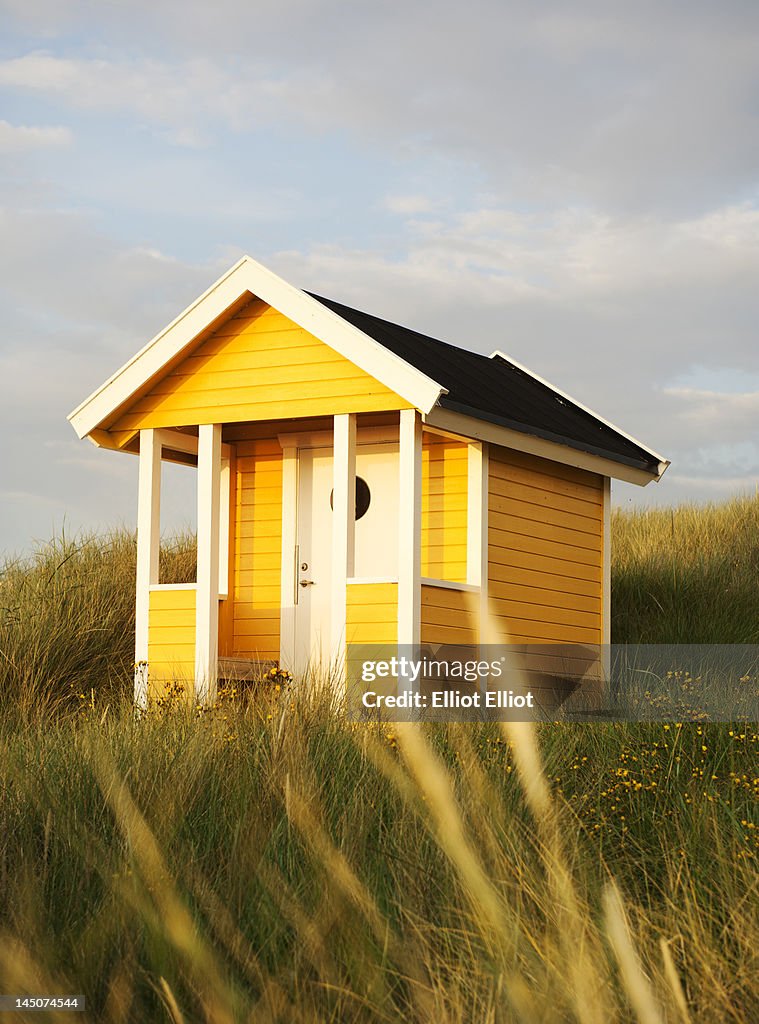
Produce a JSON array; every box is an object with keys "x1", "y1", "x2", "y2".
[{"x1": 0, "y1": 501, "x2": 759, "y2": 1024}]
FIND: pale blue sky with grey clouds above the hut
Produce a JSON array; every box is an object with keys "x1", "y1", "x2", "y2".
[{"x1": 0, "y1": 0, "x2": 759, "y2": 553}]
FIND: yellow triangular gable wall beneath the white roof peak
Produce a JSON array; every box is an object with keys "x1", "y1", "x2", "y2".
[{"x1": 109, "y1": 299, "x2": 411, "y2": 432}]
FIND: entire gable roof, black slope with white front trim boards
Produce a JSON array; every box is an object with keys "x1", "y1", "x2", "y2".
[{"x1": 69, "y1": 256, "x2": 669, "y2": 482}]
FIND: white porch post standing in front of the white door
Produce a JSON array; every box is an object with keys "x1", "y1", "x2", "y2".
[{"x1": 330, "y1": 413, "x2": 355, "y2": 682}]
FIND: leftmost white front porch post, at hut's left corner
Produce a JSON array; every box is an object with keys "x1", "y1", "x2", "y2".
[{"x1": 134, "y1": 430, "x2": 161, "y2": 709}]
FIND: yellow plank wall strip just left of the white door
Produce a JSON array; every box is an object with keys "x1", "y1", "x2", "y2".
[{"x1": 231, "y1": 431, "x2": 282, "y2": 660}]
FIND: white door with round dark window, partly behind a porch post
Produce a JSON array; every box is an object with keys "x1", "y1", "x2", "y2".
[{"x1": 295, "y1": 443, "x2": 398, "y2": 674}]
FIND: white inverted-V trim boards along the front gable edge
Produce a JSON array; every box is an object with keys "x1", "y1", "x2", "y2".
[{"x1": 69, "y1": 256, "x2": 447, "y2": 437}]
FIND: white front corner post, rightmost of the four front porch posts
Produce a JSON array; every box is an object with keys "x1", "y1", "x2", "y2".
[{"x1": 398, "y1": 409, "x2": 422, "y2": 644}]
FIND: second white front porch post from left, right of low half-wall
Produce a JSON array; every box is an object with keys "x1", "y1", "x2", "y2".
[{"x1": 195, "y1": 423, "x2": 221, "y2": 705}]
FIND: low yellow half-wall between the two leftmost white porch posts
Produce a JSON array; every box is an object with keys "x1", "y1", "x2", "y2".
[{"x1": 147, "y1": 589, "x2": 196, "y2": 699}]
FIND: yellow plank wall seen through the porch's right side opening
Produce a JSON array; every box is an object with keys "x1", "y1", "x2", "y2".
[{"x1": 422, "y1": 432, "x2": 469, "y2": 583}]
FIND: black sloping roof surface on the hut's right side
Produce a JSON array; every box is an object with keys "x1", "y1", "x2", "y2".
[{"x1": 308, "y1": 292, "x2": 666, "y2": 476}]
